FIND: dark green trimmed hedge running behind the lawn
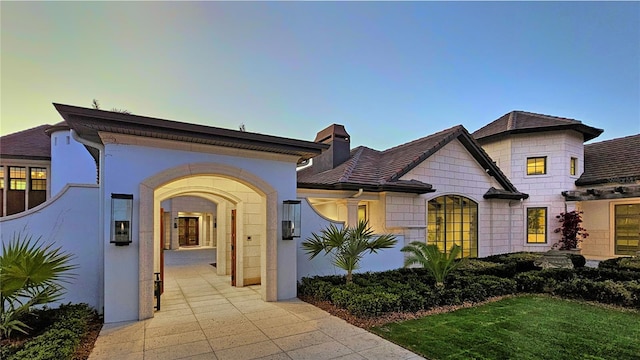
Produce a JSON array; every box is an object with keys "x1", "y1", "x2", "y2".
[{"x1": 298, "y1": 253, "x2": 640, "y2": 317}]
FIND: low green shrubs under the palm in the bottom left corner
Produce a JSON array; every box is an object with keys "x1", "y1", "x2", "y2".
[{"x1": 0, "y1": 304, "x2": 96, "y2": 360}]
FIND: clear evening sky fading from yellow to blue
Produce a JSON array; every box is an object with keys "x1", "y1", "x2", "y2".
[{"x1": 0, "y1": 1, "x2": 640, "y2": 150}]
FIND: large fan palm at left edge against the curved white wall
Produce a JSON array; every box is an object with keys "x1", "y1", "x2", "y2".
[{"x1": 0, "y1": 233, "x2": 77, "y2": 337}]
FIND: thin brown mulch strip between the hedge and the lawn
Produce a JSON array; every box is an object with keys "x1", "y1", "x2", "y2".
[{"x1": 300, "y1": 295, "x2": 513, "y2": 330}]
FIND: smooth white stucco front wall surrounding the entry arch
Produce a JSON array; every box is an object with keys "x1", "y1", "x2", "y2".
[{"x1": 101, "y1": 134, "x2": 296, "y2": 322}]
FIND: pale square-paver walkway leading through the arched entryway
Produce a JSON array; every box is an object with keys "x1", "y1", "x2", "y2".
[{"x1": 89, "y1": 250, "x2": 422, "y2": 360}]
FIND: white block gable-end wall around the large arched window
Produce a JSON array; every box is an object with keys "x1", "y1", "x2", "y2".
[{"x1": 398, "y1": 140, "x2": 522, "y2": 256}]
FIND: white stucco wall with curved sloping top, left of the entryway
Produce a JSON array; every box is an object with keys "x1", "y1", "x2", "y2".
[{"x1": 0, "y1": 185, "x2": 103, "y2": 312}]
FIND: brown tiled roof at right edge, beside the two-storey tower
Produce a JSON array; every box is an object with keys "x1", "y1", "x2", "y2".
[{"x1": 576, "y1": 134, "x2": 640, "y2": 186}]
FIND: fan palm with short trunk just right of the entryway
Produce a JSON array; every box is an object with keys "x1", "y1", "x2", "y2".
[{"x1": 302, "y1": 220, "x2": 398, "y2": 284}]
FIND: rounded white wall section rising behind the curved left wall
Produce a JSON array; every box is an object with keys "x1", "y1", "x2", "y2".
[{"x1": 50, "y1": 130, "x2": 98, "y2": 196}]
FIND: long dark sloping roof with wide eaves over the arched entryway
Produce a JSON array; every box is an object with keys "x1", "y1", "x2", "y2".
[{"x1": 53, "y1": 103, "x2": 329, "y2": 161}]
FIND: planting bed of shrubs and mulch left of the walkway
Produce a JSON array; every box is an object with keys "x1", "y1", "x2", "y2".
[{"x1": 0, "y1": 304, "x2": 102, "y2": 360}]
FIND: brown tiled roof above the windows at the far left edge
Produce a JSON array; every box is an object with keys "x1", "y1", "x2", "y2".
[{"x1": 0, "y1": 125, "x2": 51, "y2": 160}]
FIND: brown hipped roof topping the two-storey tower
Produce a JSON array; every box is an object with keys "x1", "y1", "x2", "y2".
[{"x1": 473, "y1": 111, "x2": 603, "y2": 143}]
